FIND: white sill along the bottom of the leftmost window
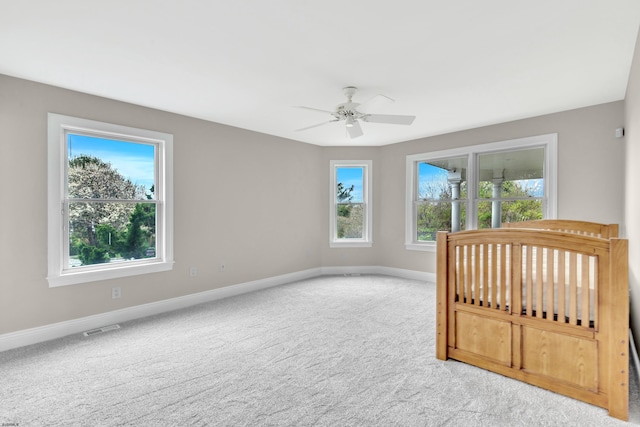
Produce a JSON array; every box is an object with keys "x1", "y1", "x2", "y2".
[{"x1": 47, "y1": 261, "x2": 173, "y2": 288}]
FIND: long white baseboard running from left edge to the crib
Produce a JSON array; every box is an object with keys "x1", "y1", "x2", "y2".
[{"x1": 0, "y1": 266, "x2": 435, "y2": 351}]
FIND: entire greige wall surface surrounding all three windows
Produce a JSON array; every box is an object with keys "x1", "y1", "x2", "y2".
[{"x1": 0, "y1": 76, "x2": 637, "y2": 342}]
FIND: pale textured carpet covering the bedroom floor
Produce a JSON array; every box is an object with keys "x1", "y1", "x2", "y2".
[{"x1": 0, "y1": 276, "x2": 640, "y2": 426}]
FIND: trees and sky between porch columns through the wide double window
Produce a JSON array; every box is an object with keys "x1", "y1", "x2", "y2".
[{"x1": 416, "y1": 163, "x2": 543, "y2": 241}]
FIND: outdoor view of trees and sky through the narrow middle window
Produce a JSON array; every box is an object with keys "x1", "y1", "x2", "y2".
[{"x1": 336, "y1": 167, "x2": 365, "y2": 239}]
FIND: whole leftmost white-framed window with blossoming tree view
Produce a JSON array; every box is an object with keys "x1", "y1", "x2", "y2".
[{"x1": 48, "y1": 114, "x2": 173, "y2": 286}]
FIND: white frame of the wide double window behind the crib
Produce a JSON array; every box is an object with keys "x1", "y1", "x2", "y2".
[{"x1": 405, "y1": 133, "x2": 558, "y2": 252}]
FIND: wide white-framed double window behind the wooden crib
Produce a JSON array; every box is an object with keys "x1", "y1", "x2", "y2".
[{"x1": 406, "y1": 134, "x2": 557, "y2": 250}]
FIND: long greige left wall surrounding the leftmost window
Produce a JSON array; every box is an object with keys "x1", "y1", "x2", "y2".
[{"x1": 0, "y1": 76, "x2": 328, "y2": 334}]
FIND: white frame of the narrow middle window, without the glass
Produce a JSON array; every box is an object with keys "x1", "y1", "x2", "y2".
[{"x1": 329, "y1": 160, "x2": 373, "y2": 248}]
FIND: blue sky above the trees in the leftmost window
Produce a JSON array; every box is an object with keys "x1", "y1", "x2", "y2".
[{"x1": 67, "y1": 134, "x2": 155, "y2": 190}]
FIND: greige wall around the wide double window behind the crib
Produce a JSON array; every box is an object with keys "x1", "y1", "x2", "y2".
[{"x1": 375, "y1": 102, "x2": 624, "y2": 271}]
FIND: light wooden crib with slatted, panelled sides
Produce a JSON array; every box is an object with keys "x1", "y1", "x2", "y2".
[{"x1": 436, "y1": 220, "x2": 629, "y2": 420}]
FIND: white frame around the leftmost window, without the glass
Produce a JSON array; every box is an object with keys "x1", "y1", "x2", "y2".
[{"x1": 47, "y1": 113, "x2": 174, "y2": 287}]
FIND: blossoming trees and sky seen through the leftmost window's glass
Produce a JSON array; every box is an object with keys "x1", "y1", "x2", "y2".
[{"x1": 67, "y1": 135, "x2": 156, "y2": 267}]
